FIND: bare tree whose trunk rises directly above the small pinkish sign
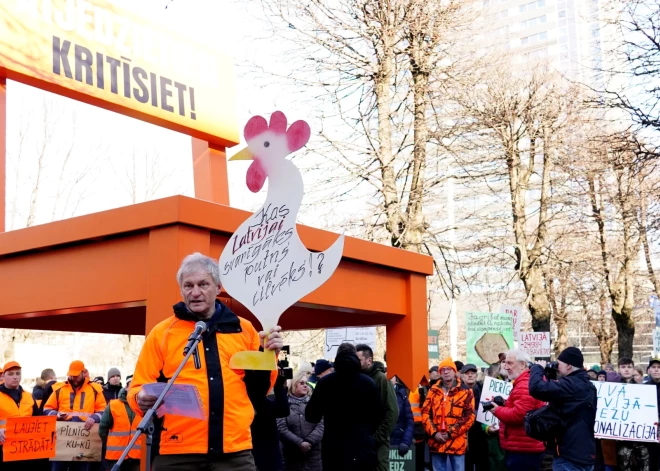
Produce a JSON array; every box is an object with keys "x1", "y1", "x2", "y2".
[{"x1": 458, "y1": 63, "x2": 575, "y2": 331}]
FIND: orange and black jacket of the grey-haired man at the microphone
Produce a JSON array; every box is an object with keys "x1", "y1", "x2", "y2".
[{"x1": 128, "y1": 303, "x2": 277, "y2": 454}]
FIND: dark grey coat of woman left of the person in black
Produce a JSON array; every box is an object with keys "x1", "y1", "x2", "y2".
[{"x1": 277, "y1": 396, "x2": 323, "y2": 471}]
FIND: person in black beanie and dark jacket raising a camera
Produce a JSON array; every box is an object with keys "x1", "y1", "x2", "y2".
[{"x1": 529, "y1": 347, "x2": 598, "y2": 471}]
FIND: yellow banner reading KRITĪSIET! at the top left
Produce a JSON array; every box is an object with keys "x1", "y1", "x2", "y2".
[{"x1": 0, "y1": 0, "x2": 239, "y2": 146}]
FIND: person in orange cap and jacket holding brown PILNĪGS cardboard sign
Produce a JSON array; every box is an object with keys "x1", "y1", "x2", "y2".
[{"x1": 44, "y1": 360, "x2": 106, "y2": 471}]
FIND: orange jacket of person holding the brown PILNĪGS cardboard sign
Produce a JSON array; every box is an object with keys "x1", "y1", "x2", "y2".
[{"x1": 44, "y1": 378, "x2": 106, "y2": 423}]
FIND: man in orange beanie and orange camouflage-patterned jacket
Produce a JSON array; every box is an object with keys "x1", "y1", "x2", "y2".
[{"x1": 422, "y1": 357, "x2": 475, "y2": 471}]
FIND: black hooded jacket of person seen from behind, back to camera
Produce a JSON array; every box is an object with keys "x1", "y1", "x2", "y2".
[{"x1": 305, "y1": 352, "x2": 384, "y2": 471}]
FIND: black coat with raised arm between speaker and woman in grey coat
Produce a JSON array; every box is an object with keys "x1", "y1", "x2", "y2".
[{"x1": 250, "y1": 376, "x2": 289, "y2": 471}]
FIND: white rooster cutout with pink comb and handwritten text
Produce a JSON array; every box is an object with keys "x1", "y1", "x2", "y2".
[{"x1": 219, "y1": 111, "x2": 344, "y2": 370}]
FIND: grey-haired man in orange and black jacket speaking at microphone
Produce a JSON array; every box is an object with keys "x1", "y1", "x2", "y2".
[{"x1": 128, "y1": 253, "x2": 282, "y2": 471}]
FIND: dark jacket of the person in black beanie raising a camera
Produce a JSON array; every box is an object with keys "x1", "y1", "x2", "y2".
[{"x1": 529, "y1": 365, "x2": 598, "y2": 466}]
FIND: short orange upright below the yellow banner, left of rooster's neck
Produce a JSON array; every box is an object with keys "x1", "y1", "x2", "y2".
[{"x1": 192, "y1": 137, "x2": 229, "y2": 206}]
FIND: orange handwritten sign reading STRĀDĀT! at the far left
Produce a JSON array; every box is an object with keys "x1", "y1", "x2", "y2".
[{"x1": 3, "y1": 416, "x2": 56, "y2": 461}]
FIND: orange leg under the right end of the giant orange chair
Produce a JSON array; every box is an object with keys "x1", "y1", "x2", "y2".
[{"x1": 387, "y1": 273, "x2": 429, "y2": 389}]
